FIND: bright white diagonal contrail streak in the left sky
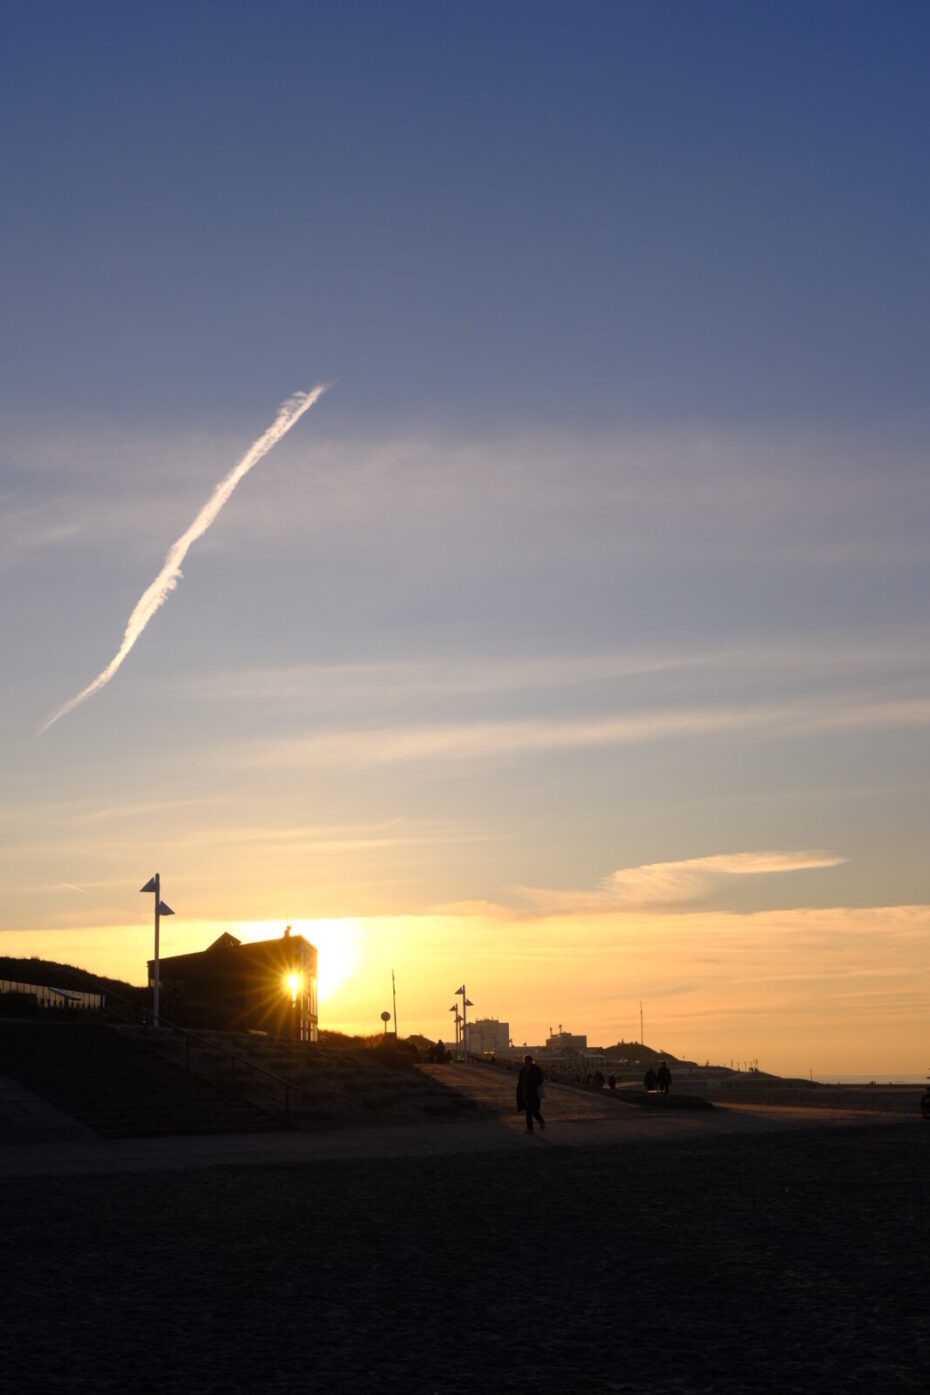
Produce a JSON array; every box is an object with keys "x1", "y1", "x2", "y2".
[{"x1": 39, "y1": 382, "x2": 329, "y2": 735}]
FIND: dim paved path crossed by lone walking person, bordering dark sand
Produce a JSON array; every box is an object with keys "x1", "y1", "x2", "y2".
[{"x1": 0, "y1": 1066, "x2": 910, "y2": 1177}]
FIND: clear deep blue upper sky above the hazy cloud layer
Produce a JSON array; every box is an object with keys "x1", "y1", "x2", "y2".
[{"x1": 3, "y1": 3, "x2": 930, "y2": 424}]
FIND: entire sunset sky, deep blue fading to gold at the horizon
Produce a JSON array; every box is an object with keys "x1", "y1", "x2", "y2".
[{"x1": 0, "y1": 0, "x2": 930, "y2": 1076}]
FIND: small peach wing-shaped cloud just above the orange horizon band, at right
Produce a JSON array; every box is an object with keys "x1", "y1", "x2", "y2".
[{"x1": 516, "y1": 851, "x2": 846, "y2": 914}]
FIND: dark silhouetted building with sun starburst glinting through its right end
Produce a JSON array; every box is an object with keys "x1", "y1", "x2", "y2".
[{"x1": 149, "y1": 926, "x2": 319, "y2": 1042}]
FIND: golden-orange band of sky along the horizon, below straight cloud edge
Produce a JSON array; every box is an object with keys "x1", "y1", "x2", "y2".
[{"x1": 0, "y1": 897, "x2": 930, "y2": 1078}]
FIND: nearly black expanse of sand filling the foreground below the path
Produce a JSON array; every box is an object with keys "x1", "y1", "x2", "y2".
[{"x1": 0, "y1": 1117, "x2": 930, "y2": 1395}]
